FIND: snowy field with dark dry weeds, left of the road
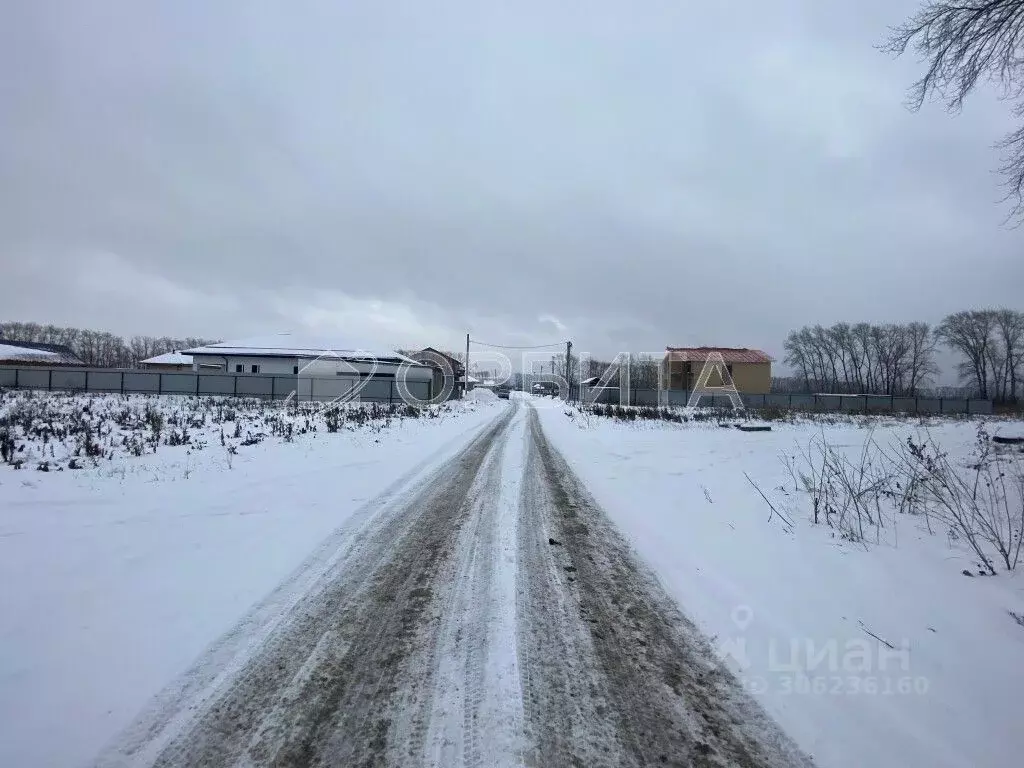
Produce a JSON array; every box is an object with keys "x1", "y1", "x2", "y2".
[{"x1": 0, "y1": 392, "x2": 503, "y2": 767}]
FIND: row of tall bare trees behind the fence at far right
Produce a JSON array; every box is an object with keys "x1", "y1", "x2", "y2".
[{"x1": 778, "y1": 309, "x2": 1024, "y2": 402}]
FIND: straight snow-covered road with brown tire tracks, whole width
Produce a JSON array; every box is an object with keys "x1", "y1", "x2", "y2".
[{"x1": 86, "y1": 401, "x2": 807, "y2": 766}]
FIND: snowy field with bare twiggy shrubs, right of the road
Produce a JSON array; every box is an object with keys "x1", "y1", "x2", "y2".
[{"x1": 539, "y1": 401, "x2": 1024, "y2": 768}]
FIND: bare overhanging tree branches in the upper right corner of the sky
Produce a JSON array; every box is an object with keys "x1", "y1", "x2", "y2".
[{"x1": 883, "y1": 0, "x2": 1024, "y2": 217}]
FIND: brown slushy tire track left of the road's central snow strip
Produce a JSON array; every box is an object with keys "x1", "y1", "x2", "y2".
[{"x1": 92, "y1": 409, "x2": 513, "y2": 766}]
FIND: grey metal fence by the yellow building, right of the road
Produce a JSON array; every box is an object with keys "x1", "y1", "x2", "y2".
[{"x1": 583, "y1": 387, "x2": 992, "y2": 415}]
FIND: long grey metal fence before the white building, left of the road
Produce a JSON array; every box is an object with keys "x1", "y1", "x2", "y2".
[{"x1": 0, "y1": 366, "x2": 432, "y2": 403}]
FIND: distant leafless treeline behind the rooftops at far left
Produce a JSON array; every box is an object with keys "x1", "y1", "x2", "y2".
[{"x1": 0, "y1": 323, "x2": 212, "y2": 368}]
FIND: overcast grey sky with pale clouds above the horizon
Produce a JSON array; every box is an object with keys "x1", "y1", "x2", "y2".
[{"x1": 0, "y1": 0, "x2": 1024, "y2": 366}]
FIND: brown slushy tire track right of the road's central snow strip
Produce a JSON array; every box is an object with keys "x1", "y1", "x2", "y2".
[{"x1": 519, "y1": 409, "x2": 812, "y2": 768}]
